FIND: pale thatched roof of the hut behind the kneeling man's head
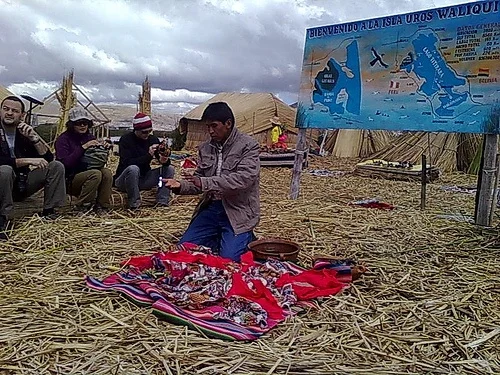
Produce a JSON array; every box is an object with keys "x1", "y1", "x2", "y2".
[{"x1": 179, "y1": 92, "x2": 297, "y2": 135}]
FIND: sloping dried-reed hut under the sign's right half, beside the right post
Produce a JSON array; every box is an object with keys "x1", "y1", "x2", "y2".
[{"x1": 370, "y1": 132, "x2": 482, "y2": 174}]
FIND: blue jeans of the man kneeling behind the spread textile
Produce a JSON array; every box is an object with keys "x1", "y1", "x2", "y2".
[{"x1": 179, "y1": 201, "x2": 255, "y2": 262}]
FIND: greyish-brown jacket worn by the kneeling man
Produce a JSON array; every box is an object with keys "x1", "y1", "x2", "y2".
[{"x1": 179, "y1": 127, "x2": 260, "y2": 234}]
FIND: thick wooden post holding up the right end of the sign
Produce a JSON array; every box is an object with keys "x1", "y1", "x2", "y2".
[{"x1": 475, "y1": 134, "x2": 498, "y2": 227}]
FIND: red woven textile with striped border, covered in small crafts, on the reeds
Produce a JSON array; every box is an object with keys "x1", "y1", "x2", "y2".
[{"x1": 86, "y1": 244, "x2": 351, "y2": 340}]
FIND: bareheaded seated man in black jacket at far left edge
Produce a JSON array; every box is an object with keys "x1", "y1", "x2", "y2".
[{"x1": 0, "y1": 96, "x2": 66, "y2": 240}]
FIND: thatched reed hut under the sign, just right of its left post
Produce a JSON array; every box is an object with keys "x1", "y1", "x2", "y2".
[{"x1": 323, "y1": 129, "x2": 393, "y2": 158}]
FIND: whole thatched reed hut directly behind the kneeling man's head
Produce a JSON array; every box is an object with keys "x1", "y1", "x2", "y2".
[{"x1": 179, "y1": 92, "x2": 312, "y2": 149}]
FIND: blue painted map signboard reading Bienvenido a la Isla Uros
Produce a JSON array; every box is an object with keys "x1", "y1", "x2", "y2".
[{"x1": 297, "y1": 1, "x2": 500, "y2": 133}]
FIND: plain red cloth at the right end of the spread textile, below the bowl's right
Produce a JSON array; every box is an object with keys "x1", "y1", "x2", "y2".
[{"x1": 276, "y1": 269, "x2": 345, "y2": 301}]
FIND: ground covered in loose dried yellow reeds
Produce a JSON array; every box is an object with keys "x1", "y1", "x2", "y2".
[{"x1": 0, "y1": 156, "x2": 500, "y2": 374}]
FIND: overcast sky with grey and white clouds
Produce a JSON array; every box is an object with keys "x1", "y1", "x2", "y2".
[{"x1": 0, "y1": 0, "x2": 474, "y2": 112}]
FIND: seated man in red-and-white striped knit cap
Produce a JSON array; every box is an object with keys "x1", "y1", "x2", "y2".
[{"x1": 115, "y1": 113, "x2": 174, "y2": 210}]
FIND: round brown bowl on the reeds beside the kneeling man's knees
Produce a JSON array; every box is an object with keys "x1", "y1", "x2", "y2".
[{"x1": 248, "y1": 238, "x2": 300, "y2": 262}]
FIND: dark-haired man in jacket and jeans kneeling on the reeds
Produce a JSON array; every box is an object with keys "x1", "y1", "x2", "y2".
[{"x1": 165, "y1": 102, "x2": 260, "y2": 261}]
